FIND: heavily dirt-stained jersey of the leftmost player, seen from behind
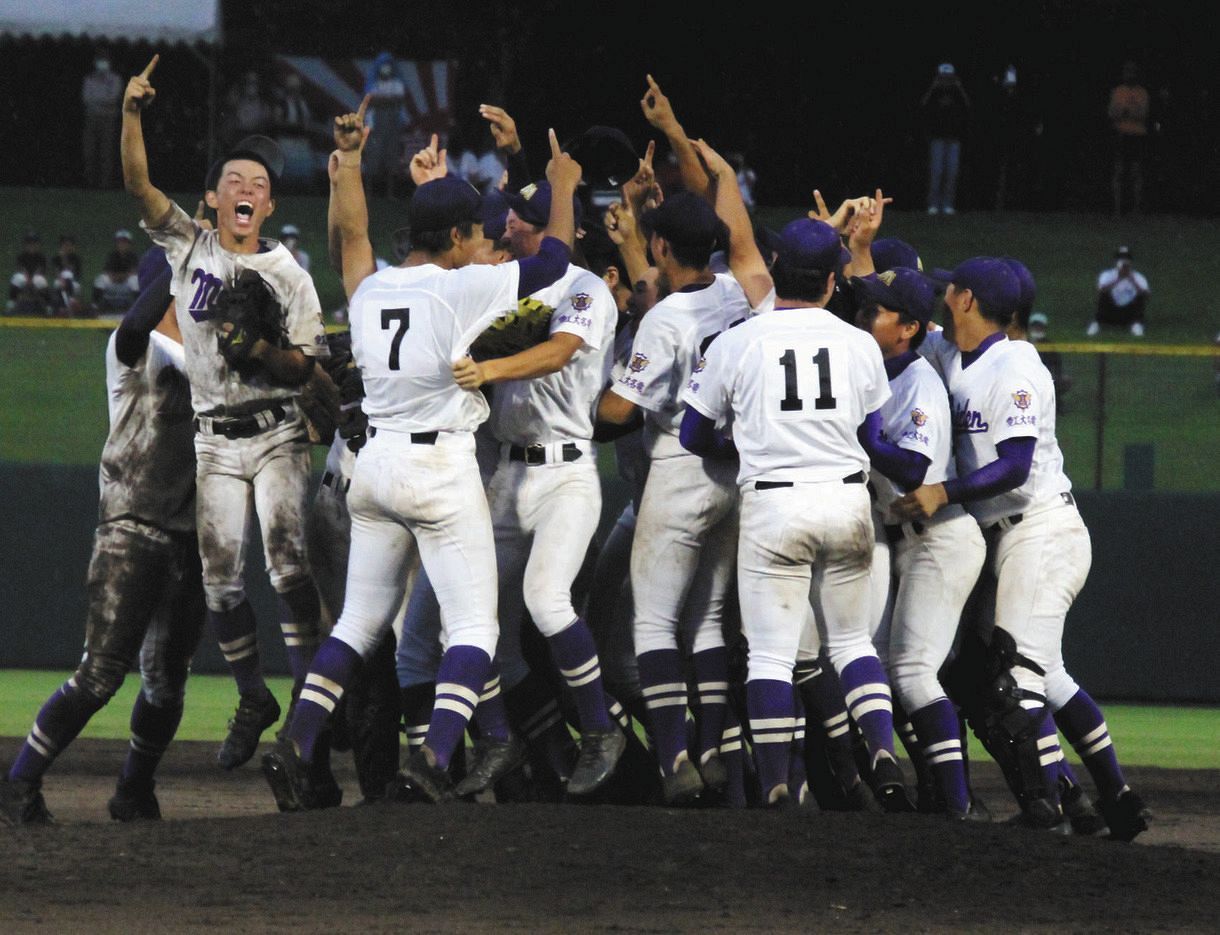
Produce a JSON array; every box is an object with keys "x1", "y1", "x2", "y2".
[{"x1": 98, "y1": 331, "x2": 195, "y2": 532}]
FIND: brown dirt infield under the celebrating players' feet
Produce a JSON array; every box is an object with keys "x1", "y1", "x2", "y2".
[{"x1": 0, "y1": 740, "x2": 1220, "y2": 933}]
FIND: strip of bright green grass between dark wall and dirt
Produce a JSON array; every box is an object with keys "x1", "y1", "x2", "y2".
[{"x1": 0, "y1": 669, "x2": 1220, "y2": 769}]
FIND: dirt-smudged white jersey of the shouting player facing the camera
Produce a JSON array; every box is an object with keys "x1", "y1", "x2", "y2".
[{"x1": 140, "y1": 204, "x2": 329, "y2": 415}]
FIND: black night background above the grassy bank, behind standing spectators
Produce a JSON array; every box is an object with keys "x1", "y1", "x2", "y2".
[{"x1": 0, "y1": 0, "x2": 1220, "y2": 214}]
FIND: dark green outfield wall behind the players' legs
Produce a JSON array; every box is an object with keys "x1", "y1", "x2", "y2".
[{"x1": 0, "y1": 463, "x2": 1220, "y2": 702}]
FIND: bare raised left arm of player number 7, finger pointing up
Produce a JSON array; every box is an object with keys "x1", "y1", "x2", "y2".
[{"x1": 328, "y1": 94, "x2": 377, "y2": 300}]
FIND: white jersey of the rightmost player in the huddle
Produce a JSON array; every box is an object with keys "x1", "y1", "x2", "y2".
[{"x1": 946, "y1": 337, "x2": 1071, "y2": 527}]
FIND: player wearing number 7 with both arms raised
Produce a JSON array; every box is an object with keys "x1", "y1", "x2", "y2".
[{"x1": 262, "y1": 98, "x2": 580, "y2": 810}]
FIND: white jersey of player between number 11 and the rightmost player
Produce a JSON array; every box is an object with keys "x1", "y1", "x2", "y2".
[{"x1": 871, "y1": 356, "x2": 956, "y2": 525}]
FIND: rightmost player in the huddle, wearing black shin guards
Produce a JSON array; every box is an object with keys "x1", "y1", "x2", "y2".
[{"x1": 891, "y1": 256, "x2": 1147, "y2": 841}]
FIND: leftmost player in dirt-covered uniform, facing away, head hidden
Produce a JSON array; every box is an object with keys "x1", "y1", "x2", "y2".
[{"x1": 0, "y1": 259, "x2": 204, "y2": 824}]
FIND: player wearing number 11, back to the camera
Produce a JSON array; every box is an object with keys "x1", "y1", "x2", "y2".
[{"x1": 678, "y1": 146, "x2": 910, "y2": 810}]
